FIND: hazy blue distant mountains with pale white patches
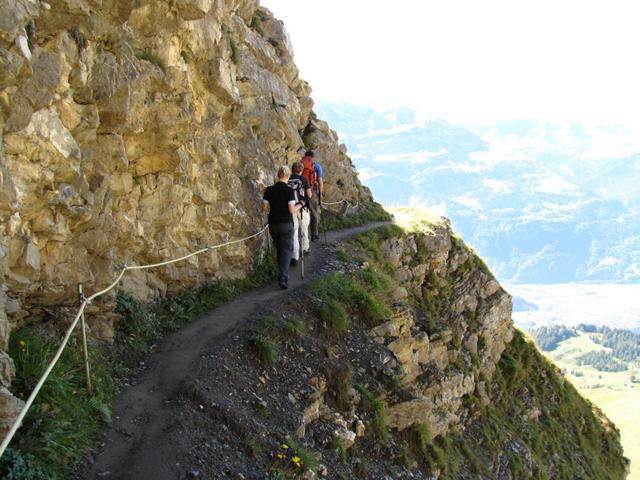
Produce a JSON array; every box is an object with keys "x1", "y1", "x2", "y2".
[{"x1": 316, "y1": 103, "x2": 640, "y2": 283}]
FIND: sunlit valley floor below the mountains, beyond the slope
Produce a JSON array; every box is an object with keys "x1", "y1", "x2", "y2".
[{"x1": 506, "y1": 283, "x2": 640, "y2": 480}]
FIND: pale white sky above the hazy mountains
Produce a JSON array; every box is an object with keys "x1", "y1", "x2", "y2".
[{"x1": 261, "y1": 0, "x2": 640, "y2": 126}]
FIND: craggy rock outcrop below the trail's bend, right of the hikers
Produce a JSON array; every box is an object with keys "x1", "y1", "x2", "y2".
[{"x1": 370, "y1": 222, "x2": 513, "y2": 436}]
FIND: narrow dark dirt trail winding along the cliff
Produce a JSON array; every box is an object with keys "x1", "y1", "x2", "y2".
[{"x1": 75, "y1": 222, "x2": 388, "y2": 480}]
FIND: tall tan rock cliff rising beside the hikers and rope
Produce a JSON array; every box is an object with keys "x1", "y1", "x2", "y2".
[{"x1": 0, "y1": 0, "x2": 370, "y2": 420}]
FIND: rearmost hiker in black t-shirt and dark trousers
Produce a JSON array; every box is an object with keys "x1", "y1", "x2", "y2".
[{"x1": 262, "y1": 165, "x2": 301, "y2": 288}]
